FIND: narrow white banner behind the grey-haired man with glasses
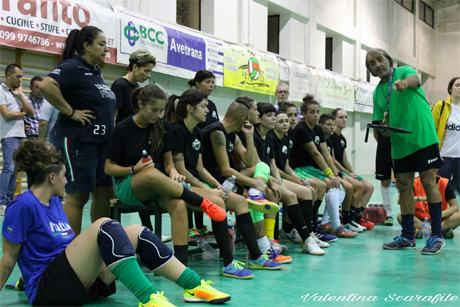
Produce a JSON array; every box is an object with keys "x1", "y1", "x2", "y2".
[{"x1": 287, "y1": 60, "x2": 317, "y2": 101}]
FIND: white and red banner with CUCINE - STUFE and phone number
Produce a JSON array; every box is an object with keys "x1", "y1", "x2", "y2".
[{"x1": 0, "y1": 0, "x2": 117, "y2": 64}]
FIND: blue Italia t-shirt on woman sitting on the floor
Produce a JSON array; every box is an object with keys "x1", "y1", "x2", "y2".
[{"x1": 2, "y1": 191, "x2": 75, "y2": 304}]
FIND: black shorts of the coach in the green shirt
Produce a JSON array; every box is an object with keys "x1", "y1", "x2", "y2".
[{"x1": 393, "y1": 143, "x2": 442, "y2": 174}]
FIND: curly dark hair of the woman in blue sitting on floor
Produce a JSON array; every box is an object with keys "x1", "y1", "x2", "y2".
[{"x1": 13, "y1": 139, "x2": 65, "y2": 185}]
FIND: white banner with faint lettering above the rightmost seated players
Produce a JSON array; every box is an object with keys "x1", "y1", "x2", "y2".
[{"x1": 316, "y1": 69, "x2": 355, "y2": 112}]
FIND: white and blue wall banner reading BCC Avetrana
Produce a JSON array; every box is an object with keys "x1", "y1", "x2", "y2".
[{"x1": 116, "y1": 7, "x2": 224, "y2": 86}]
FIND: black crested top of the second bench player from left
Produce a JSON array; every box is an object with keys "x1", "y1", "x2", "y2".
[{"x1": 172, "y1": 120, "x2": 204, "y2": 178}]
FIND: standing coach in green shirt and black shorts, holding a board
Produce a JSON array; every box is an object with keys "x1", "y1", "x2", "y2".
[{"x1": 366, "y1": 49, "x2": 445, "y2": 255}]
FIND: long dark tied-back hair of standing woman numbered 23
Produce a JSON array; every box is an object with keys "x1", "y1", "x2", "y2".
[{"x1": 61, "y1": 26, "x2": 103, "y2": 61}]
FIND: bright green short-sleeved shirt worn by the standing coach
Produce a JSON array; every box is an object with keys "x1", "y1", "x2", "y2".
[{"x1": 372, "y1": 66, "x2": 438, "y2": 159}]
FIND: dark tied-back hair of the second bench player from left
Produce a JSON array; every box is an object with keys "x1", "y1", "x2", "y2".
[{"x1": 164, "y1": 89, "x2": 206, "y2": 124}]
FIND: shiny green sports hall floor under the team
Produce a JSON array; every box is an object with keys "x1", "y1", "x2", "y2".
[{"x1": 0, "y1": 176, "x2": 460, "y2": 307}]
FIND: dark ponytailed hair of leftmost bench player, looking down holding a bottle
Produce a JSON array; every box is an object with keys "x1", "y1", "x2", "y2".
[{"x1": 131, "y1": 84, "x2": 166, "y2": 152}]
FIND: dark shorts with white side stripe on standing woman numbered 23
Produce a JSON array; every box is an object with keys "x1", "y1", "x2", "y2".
[{"x1": 53, "y1": 132, "x2": 113, "y2": 194}]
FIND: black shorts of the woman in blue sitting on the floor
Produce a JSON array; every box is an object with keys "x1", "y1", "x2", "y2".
[{"x1": 32, "y1": 250, "x2": 116, "y2": 306}]
